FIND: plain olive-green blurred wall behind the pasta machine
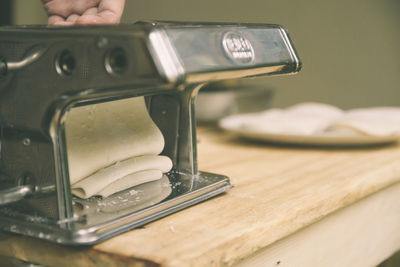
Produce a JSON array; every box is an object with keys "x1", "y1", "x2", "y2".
[{"x1": 9, "y1": 0, "x2": 400, "y2": 108}]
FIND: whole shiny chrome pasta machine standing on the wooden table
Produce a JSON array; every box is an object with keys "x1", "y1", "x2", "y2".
[{"x1": 0, "y1": 22, "x2": 301, "y2": 244}]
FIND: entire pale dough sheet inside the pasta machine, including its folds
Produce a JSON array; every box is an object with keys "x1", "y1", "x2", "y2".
[{"x1": 65, "y1": 97, "x2": 172, "y2": 198}]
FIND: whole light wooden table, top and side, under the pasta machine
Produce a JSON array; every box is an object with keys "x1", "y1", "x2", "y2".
[{"x1": 0, "y1": 127, "x2": 400, "y2": 266}]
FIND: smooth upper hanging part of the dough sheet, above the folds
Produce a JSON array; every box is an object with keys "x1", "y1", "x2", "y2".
[{"x1": 65, "y1": 97, "x2": 164, "y2": 184}]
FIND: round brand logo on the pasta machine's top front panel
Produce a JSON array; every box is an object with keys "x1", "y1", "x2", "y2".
[{"x1": 222, "y1": 32, "x2": 254, "y2": 64}]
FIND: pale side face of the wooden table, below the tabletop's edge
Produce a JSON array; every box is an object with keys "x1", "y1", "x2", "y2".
[{"x1": 235, "y1": 180, "x2": 400, "y2": 267}]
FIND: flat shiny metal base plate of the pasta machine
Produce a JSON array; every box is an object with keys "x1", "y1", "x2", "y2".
[{"x1": 0, "y1": 171, "x2": 232, "y2": 245}]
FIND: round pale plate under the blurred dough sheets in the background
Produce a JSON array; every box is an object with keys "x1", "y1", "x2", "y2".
[{"x1": 219, "y1": 116, "x2": 400, "y2": 146}]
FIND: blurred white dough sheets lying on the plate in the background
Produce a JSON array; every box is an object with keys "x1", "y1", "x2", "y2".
[{"x1": 221, "y1": 102, "x2": 400, "y2": 136}]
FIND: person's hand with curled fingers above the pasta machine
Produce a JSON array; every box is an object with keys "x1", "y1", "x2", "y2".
[{"x1": 42, "y1": 0, "x2": 125, "y2": 25}]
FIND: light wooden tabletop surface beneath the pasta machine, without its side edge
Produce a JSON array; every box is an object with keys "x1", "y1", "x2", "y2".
[{"x1": 0, "y1": 127, "x2": 400, "y2": 266}]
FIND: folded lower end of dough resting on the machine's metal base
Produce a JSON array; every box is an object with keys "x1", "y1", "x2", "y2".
[{"x1": 72, "y1": 155, "x2": 172, "y2": 198}]
